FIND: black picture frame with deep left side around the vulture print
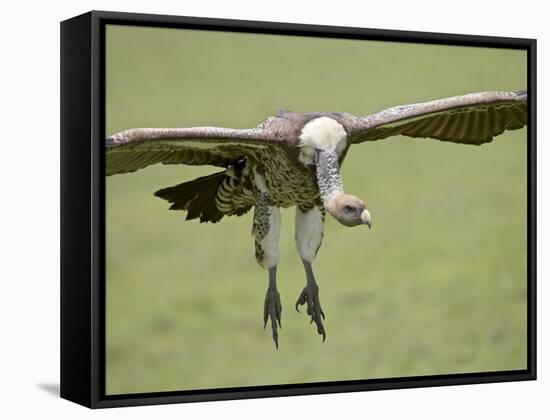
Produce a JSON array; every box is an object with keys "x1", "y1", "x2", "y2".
[{"x1": 61, "y1": 11, "x2": 536, "y2": 408}]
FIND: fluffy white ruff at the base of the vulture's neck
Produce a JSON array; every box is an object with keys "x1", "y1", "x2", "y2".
[{"x1": 298, "y1": 117, "x2": 347, "y2": 165}]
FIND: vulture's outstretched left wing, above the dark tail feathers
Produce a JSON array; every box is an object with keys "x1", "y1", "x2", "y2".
[{"x1": 105, "y1": 125, "x2": 281, "y2": 175}]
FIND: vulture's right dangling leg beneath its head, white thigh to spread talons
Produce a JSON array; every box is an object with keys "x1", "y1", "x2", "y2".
[{"x1": 295, "y1": 205, "x2": 326, "y2": 341}]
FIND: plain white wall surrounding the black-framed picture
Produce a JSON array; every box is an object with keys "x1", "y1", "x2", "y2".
[{"x1": 0, "y1": 0, "x2": 550, "y2": 420}]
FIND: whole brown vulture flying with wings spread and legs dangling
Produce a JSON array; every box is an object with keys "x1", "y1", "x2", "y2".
[{"x1": 105, "y1": 91, "x2": 527, "y2": 348}]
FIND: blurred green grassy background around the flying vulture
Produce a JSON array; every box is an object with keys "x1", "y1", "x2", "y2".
[{"x1": 106, "y1": 26, "x2": 527, "y2": 394}]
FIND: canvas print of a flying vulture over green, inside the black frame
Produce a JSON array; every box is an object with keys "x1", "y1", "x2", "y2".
[{"x1": 105, "y1": 24, "x2": 528, "y2": 395}]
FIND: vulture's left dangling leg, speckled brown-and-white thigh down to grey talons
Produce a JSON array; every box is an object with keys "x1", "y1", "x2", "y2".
[{"x1": 253, "y1": 192, "x2": 283, "y2": 348}]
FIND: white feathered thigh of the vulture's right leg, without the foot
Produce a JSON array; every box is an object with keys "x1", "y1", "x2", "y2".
[{"x1": 295, "y1": 207, "x2": 323, "y2": 262}]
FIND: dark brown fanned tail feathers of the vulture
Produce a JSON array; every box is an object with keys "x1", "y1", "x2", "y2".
[{"x1": 155, "y1": 171, "x2": 226, "y2": 223}]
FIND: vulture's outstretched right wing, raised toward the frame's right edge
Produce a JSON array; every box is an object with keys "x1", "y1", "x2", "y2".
[{"x1": 351, "y1": 91, "x2": 527, "y2": 145}]
